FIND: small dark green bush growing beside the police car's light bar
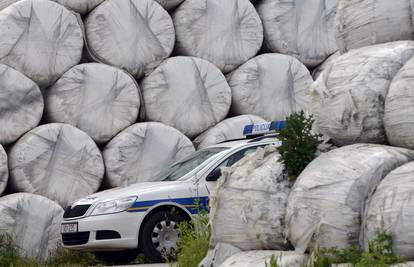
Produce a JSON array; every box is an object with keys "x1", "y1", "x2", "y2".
[{"x1": 278, "y1": 111, "x2": 321, "y2": 180}]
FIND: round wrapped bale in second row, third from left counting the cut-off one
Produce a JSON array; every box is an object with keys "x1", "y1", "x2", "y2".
[{"x1": 141, "y1": 57, "x2": 231, "y2": 138}]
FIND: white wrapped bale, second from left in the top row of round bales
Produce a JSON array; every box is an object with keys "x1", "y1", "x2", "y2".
[{"x1": 85, "y1": 0, "x2": 175, "y2": 78}]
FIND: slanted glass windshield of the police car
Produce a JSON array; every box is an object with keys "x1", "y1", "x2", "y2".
[{"x1": 157, "y1": 147, "x2": 228, "y2": 181}]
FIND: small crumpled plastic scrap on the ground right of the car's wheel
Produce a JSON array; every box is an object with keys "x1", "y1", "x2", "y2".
[{"x1": 198, "y1": 243, "x2": 241, "y2": 267}]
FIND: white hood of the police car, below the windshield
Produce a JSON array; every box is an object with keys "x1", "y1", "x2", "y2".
[{"x1": 72, "y1": 181, "x2": 183, "y2": 206}]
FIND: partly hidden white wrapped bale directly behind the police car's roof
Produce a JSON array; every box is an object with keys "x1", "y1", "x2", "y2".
[{"x1": 193, "y1": 115, "x2": 266, "y2": 149}]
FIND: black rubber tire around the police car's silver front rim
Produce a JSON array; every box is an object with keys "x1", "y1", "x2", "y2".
[{"x1": 139, "y1": 209, "x2": 187, "y2": 263}]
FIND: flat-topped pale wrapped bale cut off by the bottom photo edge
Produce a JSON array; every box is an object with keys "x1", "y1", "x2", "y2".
[{"x1": 219, "y1": 250, "x2": 308, "y2": 267}]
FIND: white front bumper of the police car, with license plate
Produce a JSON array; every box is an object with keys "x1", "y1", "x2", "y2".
[{"x1": 62, "y1": 211, "x2": 144, "y2": 251}]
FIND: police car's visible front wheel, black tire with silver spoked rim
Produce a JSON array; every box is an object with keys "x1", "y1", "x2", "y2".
[{"x1": 139, "y1": 210, "x2": 186, "y2": 262}]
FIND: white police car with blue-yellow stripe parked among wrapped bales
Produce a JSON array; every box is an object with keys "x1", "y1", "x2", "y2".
[{"x1": 61, "y1": 122, "x2": 284, "y2": 262}]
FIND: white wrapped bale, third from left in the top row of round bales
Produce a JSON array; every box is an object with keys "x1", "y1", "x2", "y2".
[{"x1": 173, "y1": 0, "x2": 263, "y2": 73}]
